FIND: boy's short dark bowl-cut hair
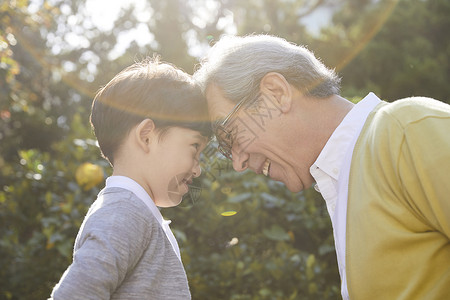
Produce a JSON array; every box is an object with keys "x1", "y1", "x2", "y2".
[{"x1": 90, "y1": 58, "x2": 212, "y2": 165}]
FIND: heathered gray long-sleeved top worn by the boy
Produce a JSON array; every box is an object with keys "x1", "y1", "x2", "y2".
[{"x1": 52, "y1": 187, "x2": 191, "y2": 300}]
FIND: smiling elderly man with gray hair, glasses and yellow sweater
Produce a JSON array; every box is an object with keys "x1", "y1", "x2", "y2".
[{"x1": 195, "y1": 35, "x2": 450, "y2": 300}]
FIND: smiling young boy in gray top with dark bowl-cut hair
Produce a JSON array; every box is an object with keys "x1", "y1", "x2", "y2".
[{"x1": 52, "y1": 60, "x2": 211, "y2": 300}]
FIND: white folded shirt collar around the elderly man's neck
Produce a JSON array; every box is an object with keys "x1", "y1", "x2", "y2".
[{"x1": 311, "y1": 93, "x2": 381, "y2": 180}]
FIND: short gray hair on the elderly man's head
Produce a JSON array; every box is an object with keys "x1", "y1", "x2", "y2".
[{"x1": 194, "y1": 35, "x2": 340, "y2": 103}]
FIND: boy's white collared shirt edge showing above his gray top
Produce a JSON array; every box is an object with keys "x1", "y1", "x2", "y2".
[{"x1": 105, "y1": 176, "x2": 181, "y2": 261}]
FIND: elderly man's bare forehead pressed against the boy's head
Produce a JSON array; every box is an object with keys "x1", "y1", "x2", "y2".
[{"x1": 205, "y1": 85, "x2": 234, "y2": 123}]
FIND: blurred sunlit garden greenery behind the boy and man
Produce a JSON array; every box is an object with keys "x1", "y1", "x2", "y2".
[{"x1": 0, "y1": 0, "x2": 450, "y2": 299}]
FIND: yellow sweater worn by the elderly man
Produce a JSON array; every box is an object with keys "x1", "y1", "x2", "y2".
[{"x1": 346, "y1": 98, "x2": 450, "y2": 300}]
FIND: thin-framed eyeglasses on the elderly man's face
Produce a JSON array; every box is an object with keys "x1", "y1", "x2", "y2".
[{"x1": 213, "y1": 94, "x2": 259, "y2": 160}]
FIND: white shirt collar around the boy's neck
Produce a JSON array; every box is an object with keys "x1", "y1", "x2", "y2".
[{"x1": 106, "y1": 176, "x2": 164, "y2": 225}]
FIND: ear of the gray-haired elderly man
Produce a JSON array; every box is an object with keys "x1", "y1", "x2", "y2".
[{"x1": 260, "y1": 72, "x2": 292, "y2": 113}]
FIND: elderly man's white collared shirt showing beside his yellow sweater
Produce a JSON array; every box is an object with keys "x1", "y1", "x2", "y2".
[{"x1": 310, "y1": 93, "x2": 381, "y2": 300}]
